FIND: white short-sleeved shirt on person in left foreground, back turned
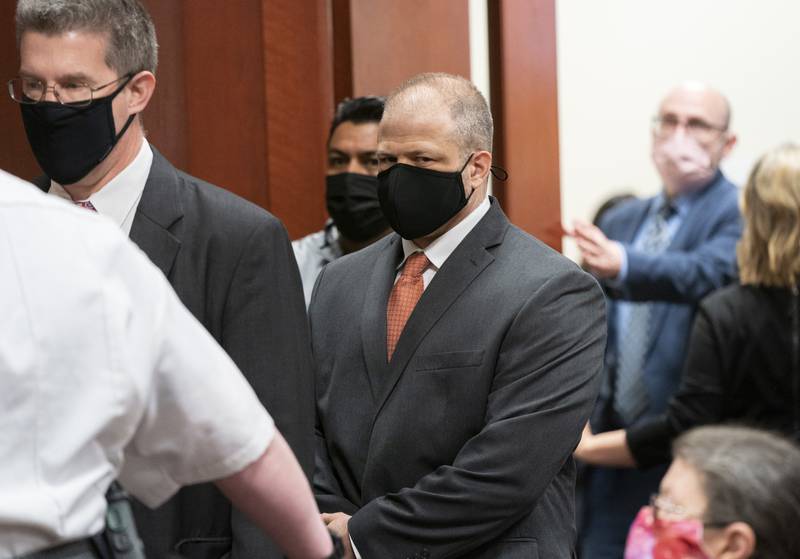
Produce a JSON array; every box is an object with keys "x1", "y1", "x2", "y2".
[{"x1": 0, "y1": 171, "x2": 274, "y2": 559}]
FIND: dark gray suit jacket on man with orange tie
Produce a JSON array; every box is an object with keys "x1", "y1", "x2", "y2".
[{"x1": 310, "y1": 199, "x2": 606, "y2": 559}]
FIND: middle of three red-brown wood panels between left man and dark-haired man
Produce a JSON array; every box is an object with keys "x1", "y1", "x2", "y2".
[{"x1": 180, "y1": 0, "x2": 270, "y2": 208}]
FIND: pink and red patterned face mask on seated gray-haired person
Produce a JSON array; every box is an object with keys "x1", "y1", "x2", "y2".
[{"x1": 625, "y1": 507, "x2": 711, "y2": 559}]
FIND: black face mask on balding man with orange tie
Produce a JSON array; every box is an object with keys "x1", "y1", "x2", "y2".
[{"x1": 378, "y1": 155, "x2": 475, "y2": 239}]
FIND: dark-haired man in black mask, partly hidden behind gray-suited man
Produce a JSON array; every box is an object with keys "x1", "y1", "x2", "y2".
[{"x1": 292, "y1": 96, "x2": 390, "y2": 305}]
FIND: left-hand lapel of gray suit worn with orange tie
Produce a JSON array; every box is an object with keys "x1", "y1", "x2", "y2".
[{"x1": 361, "y1": 235, "x2": 403, "y2": 400}]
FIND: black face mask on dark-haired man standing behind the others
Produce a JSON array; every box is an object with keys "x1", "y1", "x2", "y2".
[{"x1": 325, "y1": 173, "x2": 389, "y2": 242}]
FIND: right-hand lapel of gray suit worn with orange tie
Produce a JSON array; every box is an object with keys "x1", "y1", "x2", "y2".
[{"x1": 376, "y1": 199, "x2": 509, "y2": 416}]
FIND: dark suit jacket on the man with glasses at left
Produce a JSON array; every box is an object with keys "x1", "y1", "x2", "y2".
[{"x1": 38, "y1": 149, "x2": 314, "y2": 559}]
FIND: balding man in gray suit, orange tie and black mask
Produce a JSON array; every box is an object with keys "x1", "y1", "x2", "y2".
[{"x1": 310, "y1": 74, "x2": 605, "y2": 559}]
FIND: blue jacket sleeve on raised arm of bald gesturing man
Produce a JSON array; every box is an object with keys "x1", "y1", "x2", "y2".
[{"x1": 610, "y1": 198, "x2": 741, "y2": 304}]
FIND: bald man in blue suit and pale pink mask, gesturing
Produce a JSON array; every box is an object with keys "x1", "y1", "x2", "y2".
[{"x1": 574, "y1": 83, "x2": 741, "y2": 559}]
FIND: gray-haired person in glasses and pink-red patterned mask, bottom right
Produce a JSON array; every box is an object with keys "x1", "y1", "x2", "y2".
[{"x1": 625, "y1": 426, "x2": 800, "y2": 559}]
